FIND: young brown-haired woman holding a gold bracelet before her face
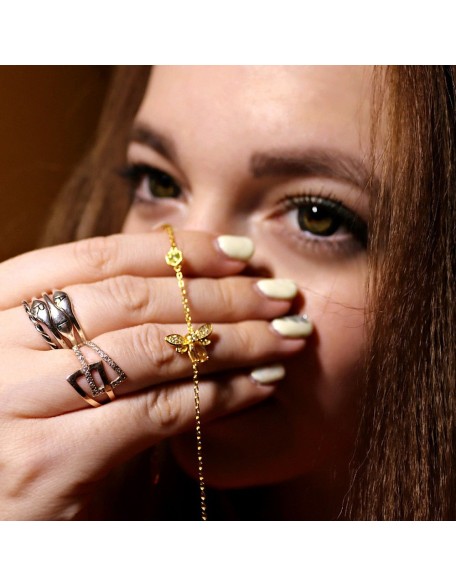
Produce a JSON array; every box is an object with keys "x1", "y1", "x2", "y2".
[{"x1": 0, "y1": 67, "x2": 455, "y2": 519}]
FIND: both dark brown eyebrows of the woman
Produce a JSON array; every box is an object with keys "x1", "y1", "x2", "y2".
[{"x1": 130, "y1": 122, "x2": 380, "y2": 194}]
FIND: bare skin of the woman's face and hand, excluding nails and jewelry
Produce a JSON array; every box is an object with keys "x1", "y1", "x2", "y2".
[{"x1": 0, "y1": 67, "x2": 370, "y2": 519}]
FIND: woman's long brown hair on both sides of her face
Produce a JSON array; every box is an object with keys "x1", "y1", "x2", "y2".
[{"x1": 43, "y1": 66, "x2": 456, "y2": 519}]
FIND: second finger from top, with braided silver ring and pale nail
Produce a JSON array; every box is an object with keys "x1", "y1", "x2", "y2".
[{"x1": 8, "y1": 275, "x2": 297, "y2": 350}]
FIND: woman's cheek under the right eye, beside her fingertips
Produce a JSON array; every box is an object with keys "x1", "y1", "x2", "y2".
[{"x1": 253, "y1": 233, "x2": 367, "y2": 421}]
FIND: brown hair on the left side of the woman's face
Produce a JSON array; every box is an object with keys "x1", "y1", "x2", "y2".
[{"x1": 40, "y1": 66, "x2": 150, "y2": 246}]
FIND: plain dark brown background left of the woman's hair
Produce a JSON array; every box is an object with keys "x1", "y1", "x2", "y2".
[{"x1": 0, "y1": 65, "x2": 112, "y2": 261}]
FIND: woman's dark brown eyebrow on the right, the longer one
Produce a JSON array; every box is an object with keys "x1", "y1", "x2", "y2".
[{"x1": 250, "y1": 149, "x2": 379, "y2": 193}]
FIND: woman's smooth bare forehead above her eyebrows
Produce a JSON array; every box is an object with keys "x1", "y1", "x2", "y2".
[{"x1": 137, "y1": 66, "x2": 372, "y2": 167}]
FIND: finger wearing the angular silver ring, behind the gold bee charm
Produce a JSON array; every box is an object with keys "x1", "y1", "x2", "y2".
[{"x1": 1, "y1": 321, "x2": 305, "y2": 417}]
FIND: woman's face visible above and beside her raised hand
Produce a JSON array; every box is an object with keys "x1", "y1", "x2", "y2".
[{"x1": 124, "y1": 66, "x2": 371, "y2": 487}]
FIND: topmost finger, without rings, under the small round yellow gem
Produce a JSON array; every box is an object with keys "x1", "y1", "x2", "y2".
[{"x1": 0, "y1": 230, "x2": 253, "y2": 309}]
